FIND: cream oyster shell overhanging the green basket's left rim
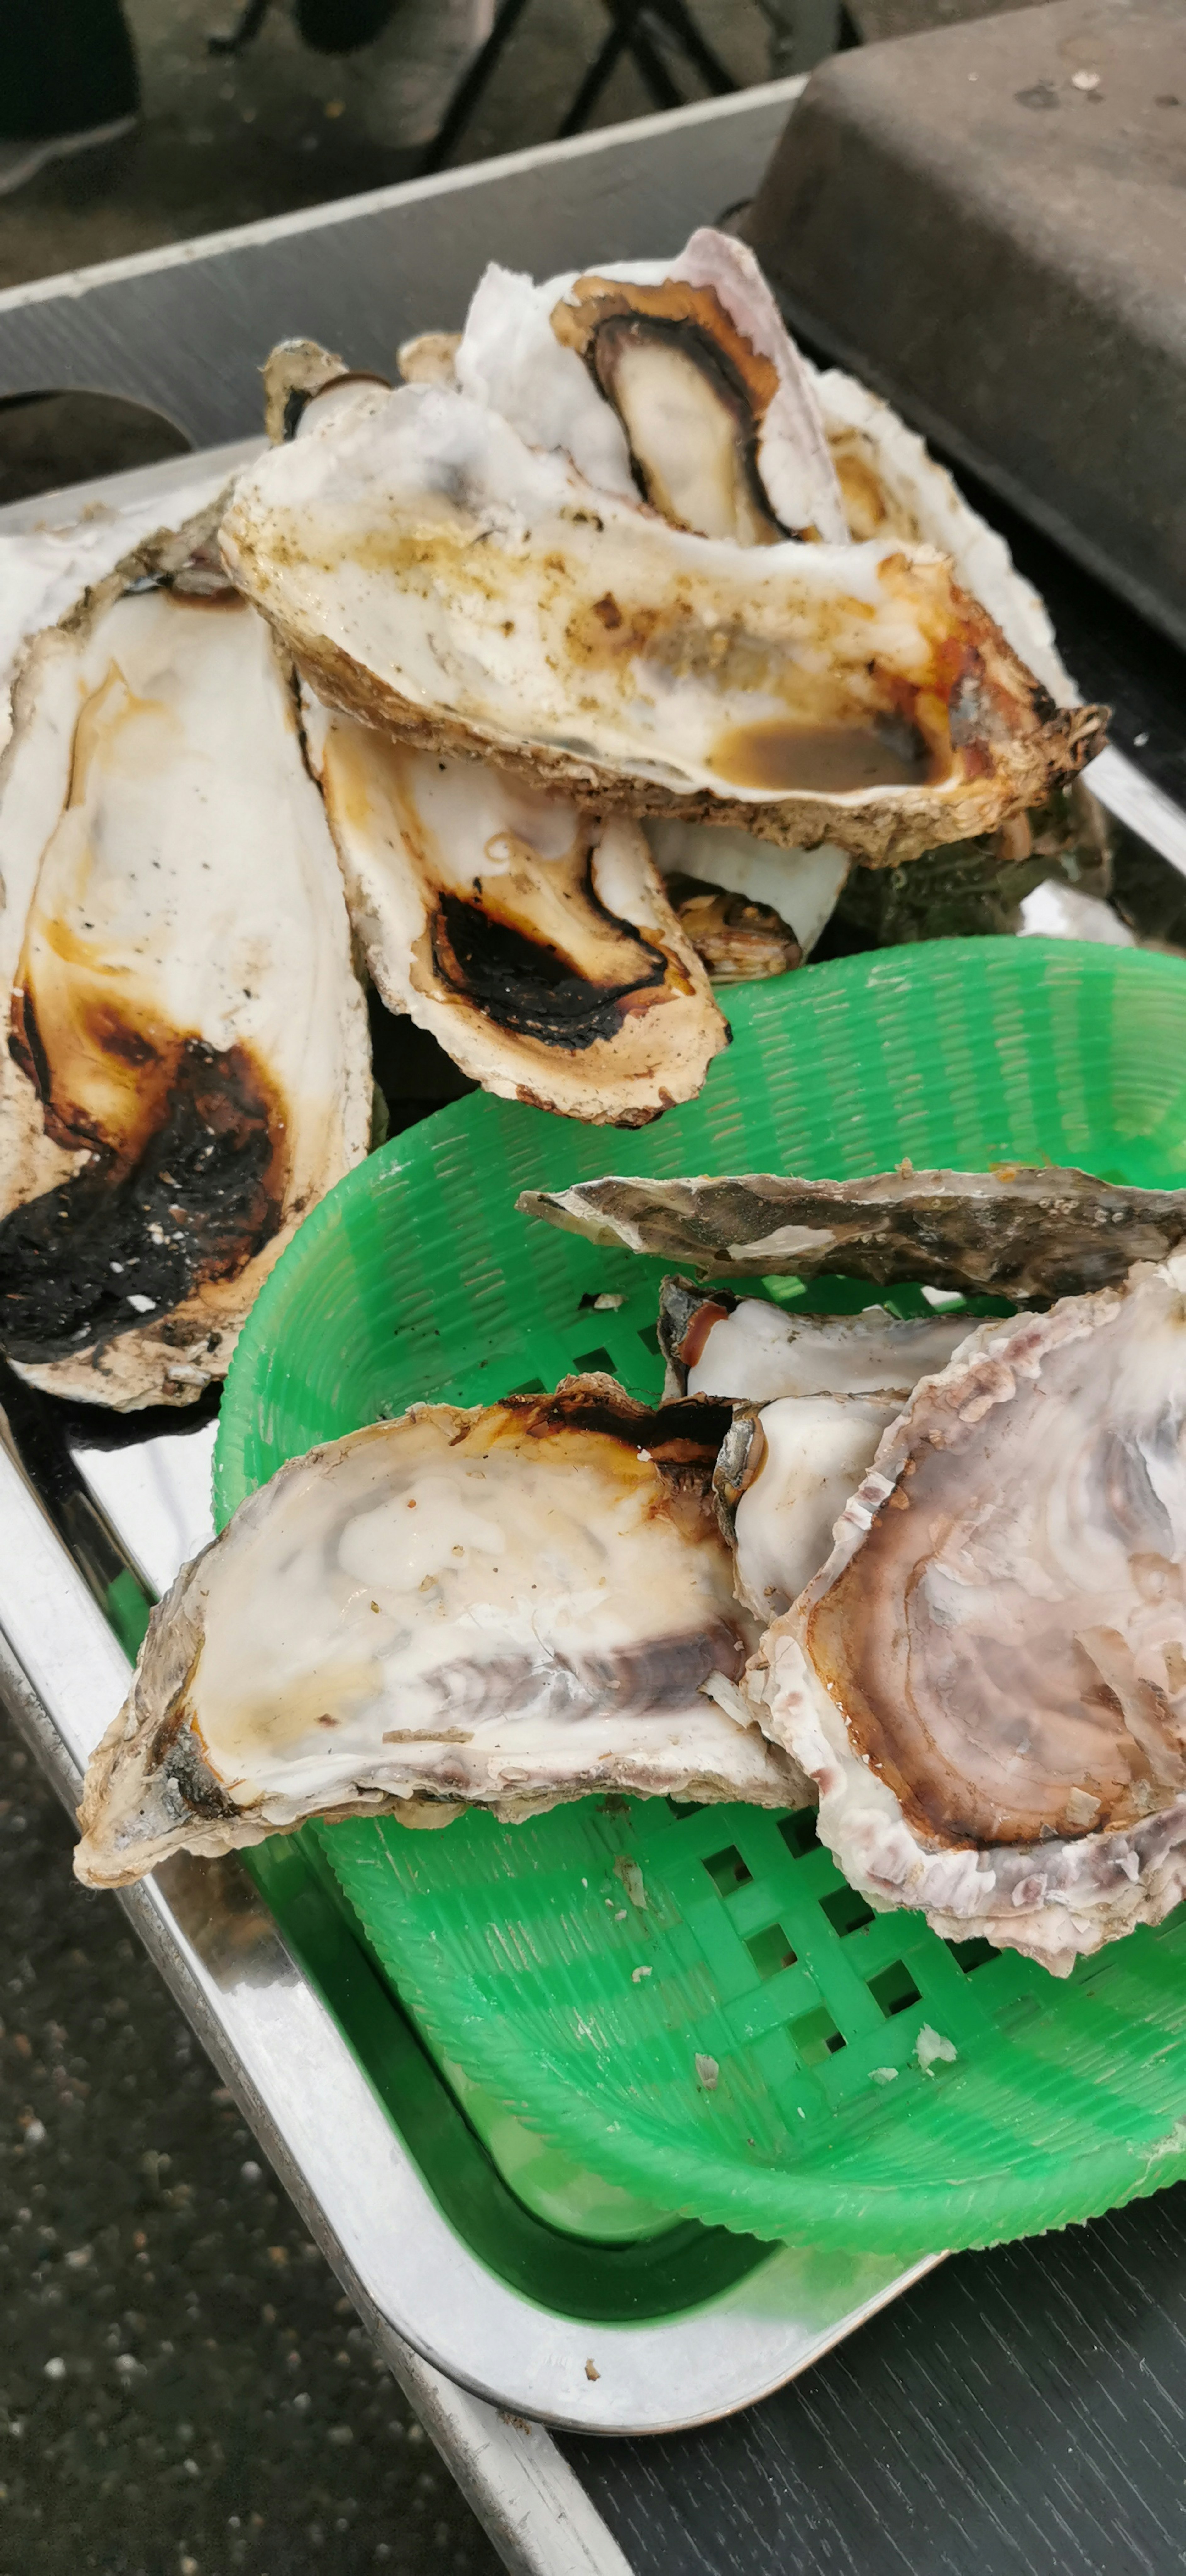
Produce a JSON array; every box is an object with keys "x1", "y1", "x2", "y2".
[{"x1": 77, "y1": 1378, "x2": 800, "y2": 1886}]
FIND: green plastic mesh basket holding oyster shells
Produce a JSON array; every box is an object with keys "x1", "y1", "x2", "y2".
[{"x1": 216, "y1": 940, "x2": 1186, "y2": 2262}]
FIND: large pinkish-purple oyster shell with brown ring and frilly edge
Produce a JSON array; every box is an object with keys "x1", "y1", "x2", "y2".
[{"x1": 754, "y1": 1255, "x2": 1186, "y2": 1973}]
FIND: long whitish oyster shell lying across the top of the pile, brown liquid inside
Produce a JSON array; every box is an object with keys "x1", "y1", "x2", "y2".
[{"x1": 221, "y1": 384, "x2": 1101, "y2": 860}]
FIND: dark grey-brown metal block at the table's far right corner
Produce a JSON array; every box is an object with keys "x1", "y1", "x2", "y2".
[{"x1": 743, "y1": 0, "x2": 1186, "y2": 644}]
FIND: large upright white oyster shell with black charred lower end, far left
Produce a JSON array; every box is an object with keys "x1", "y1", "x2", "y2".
[{"x1": 0, "y1": 508, "x2": 371, "y2": 1409}]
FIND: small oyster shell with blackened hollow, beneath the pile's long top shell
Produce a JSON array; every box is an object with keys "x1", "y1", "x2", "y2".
[{"x1": 309, "y1": 716, "x2": 728, "y2": 1126}]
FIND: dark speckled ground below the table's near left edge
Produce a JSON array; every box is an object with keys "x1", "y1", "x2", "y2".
[{"x1": 0, "y1": 1721, "x2": 499, "y2": 2576}]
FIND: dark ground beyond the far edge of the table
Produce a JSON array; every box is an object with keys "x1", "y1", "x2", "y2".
[{"x1": 0, "y1": 0, "x2": 769, "y2": 286}]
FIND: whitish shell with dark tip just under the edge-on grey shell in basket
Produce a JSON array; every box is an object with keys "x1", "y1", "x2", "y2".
[{"x1": 659, "y1": 1278, "x2": 973, "y2": 1404}]
